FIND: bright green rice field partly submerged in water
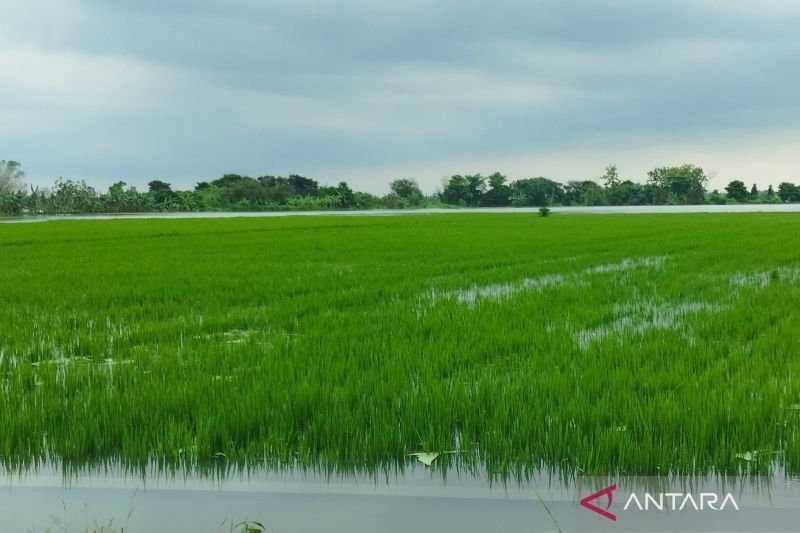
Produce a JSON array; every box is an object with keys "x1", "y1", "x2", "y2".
[{"x1": 0, "y1": 213, "x2": 800, "y2": 475}]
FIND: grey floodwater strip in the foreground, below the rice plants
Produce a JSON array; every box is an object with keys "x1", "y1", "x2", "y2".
[{"x1": 0, "y1": 465, "x2": 800, "y2": 533}]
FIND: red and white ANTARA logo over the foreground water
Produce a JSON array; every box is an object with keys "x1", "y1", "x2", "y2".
[{"x1": 580, "y1": 483, "x2": 739, "y2": 522}]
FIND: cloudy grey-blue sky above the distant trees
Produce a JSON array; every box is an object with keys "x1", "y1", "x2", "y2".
[{"x1": 0, "y1": 0, "x2": 800, "y2": 193}]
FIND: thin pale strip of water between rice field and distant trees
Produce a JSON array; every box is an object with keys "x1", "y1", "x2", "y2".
[{"x1": 0, "y1": 204, "x2": 800, "y2": 223}]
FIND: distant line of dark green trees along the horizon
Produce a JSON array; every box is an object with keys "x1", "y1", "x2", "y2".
[{"x1": 0, "y1": 160, "x2": 800, "y2": 215}]
